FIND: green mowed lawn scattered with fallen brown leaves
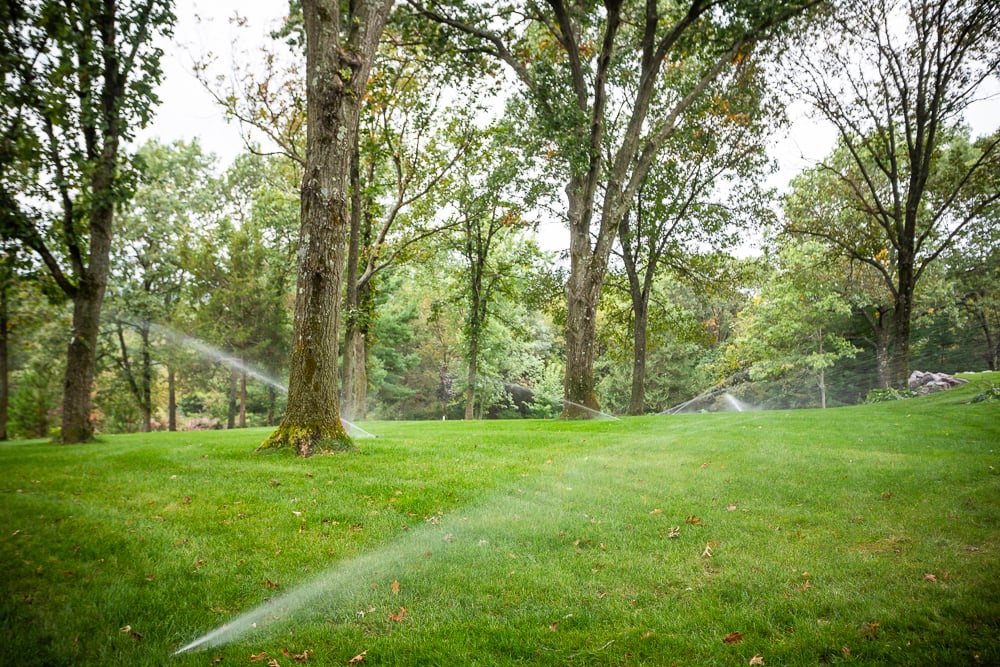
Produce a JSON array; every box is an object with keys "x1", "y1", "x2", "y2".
[{"x1": 0, "y1": 374, "x2": 1000, "y2": 666}]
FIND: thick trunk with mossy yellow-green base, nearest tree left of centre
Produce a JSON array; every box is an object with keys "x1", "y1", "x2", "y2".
[{"x1": 262, "y1": 0, "x2": 393, "y2": 456}]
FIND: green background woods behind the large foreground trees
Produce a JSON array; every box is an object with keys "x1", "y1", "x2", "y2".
[{"x1": 2, "y1": 4, "x2": 1000, "y2": 437}]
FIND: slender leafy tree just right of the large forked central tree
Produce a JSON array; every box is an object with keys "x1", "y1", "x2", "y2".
[{"x1": 612, "y1": 66, "x2": 775, "y2": 415}]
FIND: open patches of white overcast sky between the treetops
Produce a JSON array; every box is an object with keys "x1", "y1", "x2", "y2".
[{"x1": 138, "y1": 0, "x2": 1000, "y2": 251}]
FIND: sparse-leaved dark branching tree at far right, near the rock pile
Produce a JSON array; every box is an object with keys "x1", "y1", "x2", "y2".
[{"x1": 789, "y1": 0, "x2": 1000, "y2": 387}]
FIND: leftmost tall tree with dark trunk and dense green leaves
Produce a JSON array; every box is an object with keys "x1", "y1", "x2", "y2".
[{"x1": 0, "y1": 0, "x2": 174, "y2": 443}]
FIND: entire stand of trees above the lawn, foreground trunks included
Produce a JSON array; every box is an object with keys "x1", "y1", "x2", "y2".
[{"x1": 0, "y1": 0, "x2": 1000, "y2": 455}]
